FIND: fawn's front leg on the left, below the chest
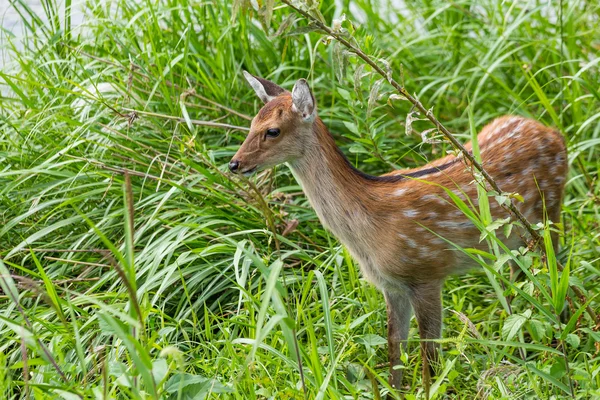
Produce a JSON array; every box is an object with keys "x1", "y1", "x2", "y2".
[{"x1": 384, "y1": 290, "x2": 411, "y2": 398}]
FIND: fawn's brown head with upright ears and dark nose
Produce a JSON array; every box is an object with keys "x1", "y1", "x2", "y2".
[{"x1": 229, "y1": 71, "x2": 317, "y2": 175}]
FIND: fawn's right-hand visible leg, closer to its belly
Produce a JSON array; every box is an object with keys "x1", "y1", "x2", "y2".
[{"x1": 410, "y1": 281, "x2": 442, "y2": 398}]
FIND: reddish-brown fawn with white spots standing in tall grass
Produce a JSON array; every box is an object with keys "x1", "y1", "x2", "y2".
[{"x1": 229, "y1": 71, "x2": 567, "y2": 394}]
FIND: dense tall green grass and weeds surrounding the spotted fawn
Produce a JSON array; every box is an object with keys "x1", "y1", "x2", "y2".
[{"x1": 0, "y1": 0, "x2": 600, "y2": 399}]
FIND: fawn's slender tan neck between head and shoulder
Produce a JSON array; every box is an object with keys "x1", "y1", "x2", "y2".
[{"x1": 290, "y1": 118, "x2": 373, "y2": 239}]
